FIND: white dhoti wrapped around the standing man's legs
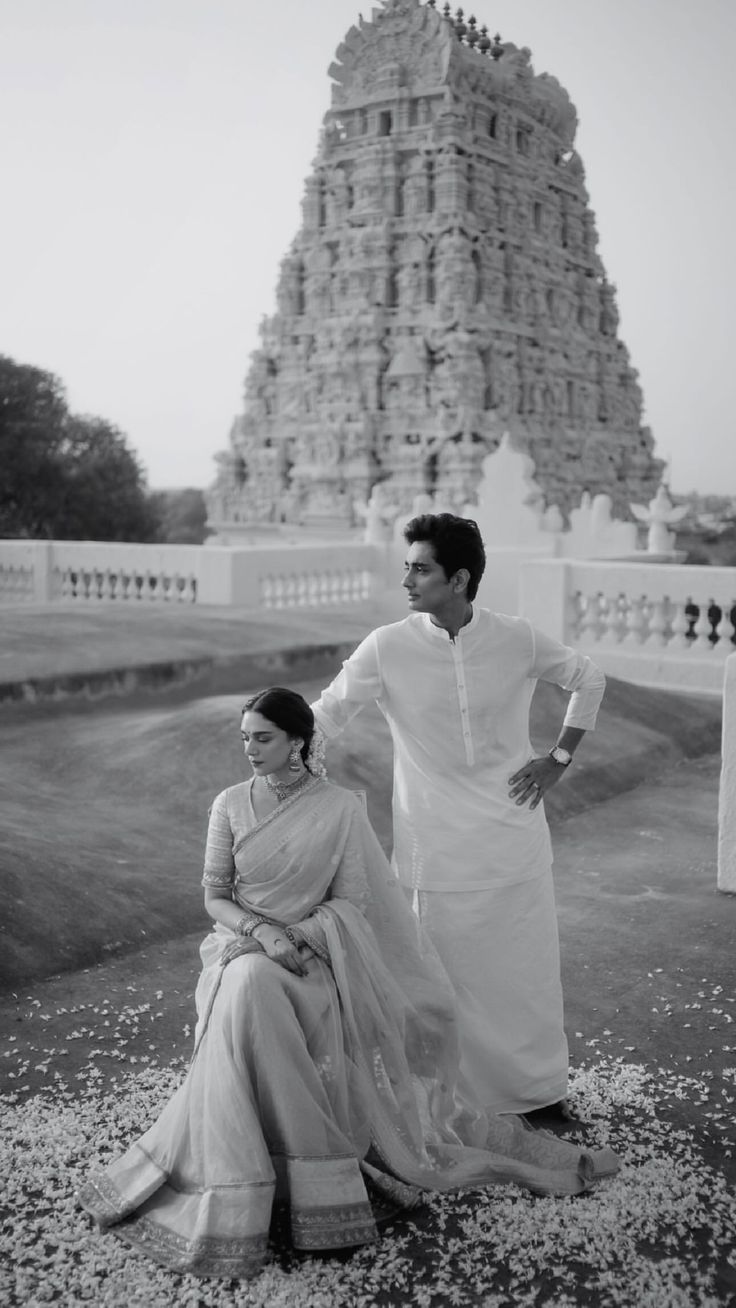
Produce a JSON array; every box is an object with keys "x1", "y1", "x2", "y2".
[{"x1": 414, "y1": 869, "x2": 567, "y2": 1113}]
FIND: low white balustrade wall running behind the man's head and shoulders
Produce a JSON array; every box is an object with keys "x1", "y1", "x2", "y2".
[{"x1": 0, "y1": 540, "x2": 736, "y2": 693}]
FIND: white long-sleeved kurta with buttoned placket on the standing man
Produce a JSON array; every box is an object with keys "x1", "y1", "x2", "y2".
[{"x1": 312, "y1": 608, "x2": 605, "y2": 892}]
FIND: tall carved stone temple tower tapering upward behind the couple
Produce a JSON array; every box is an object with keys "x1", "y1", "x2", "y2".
[{"x1": 208, "y1": 0, "x2": 663, "y2": 540}]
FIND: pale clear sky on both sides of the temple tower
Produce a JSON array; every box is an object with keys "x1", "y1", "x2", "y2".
[{"x1": 0, "y1": 0, "x2": 736, "y2": 494}]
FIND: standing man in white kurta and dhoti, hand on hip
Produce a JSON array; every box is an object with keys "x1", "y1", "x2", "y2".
[{"x1": 312, "y1": 513, "x2": 605, "y2": 1117}]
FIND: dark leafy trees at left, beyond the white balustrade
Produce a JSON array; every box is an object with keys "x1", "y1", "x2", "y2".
[{"x1": 0, "y1": 354, "x2": 207, "y2": 544}]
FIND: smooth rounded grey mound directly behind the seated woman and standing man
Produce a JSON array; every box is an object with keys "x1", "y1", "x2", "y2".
[{"x1": 0, "y1": 681, "x2": 720, "y2": 988}]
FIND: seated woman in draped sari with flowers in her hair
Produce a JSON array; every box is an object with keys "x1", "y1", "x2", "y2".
[{"x1": 80, "y1": 687, "x2": 616, "y2": 1277}]
